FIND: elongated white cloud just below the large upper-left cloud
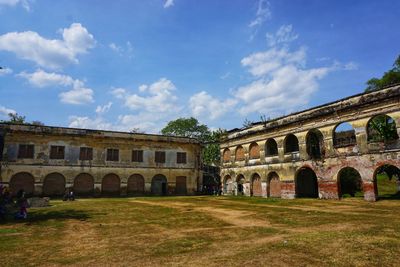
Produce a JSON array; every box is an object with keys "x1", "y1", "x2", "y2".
[{"x1": 17, "y1": 69, "x2": 94, "y2": 105}]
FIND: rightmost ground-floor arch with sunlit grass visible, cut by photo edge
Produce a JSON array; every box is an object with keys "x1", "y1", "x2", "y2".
[{"x1": 374, "y1": 164, "x2": 400, "y2": 199}]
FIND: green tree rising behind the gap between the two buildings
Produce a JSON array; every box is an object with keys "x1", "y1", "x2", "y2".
[{"x1": 161, "y1": 117, "x2": 225, "y2": 165}]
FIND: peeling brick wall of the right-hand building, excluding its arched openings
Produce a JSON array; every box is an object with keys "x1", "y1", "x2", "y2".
[{"x1": 221, "y1": 86, "x2": 400, "y2": 200}]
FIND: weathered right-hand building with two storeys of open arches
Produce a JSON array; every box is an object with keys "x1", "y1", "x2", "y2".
[{"x1": 221, "y1": 85, "x2": 400, "y2": 201}]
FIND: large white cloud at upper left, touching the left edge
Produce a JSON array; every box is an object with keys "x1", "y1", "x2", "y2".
[{"x1": 0, "y1": 23, "x2": 96, "y2": 69}]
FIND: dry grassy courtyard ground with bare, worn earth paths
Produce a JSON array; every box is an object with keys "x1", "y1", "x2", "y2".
[{"x1": 0, "y1": 197, "x2": 400, "y2": 266}]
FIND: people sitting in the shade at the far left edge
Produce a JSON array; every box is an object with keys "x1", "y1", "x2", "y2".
[{"x1": 0, "y1": 184, "x2": 28, "y2": 220}]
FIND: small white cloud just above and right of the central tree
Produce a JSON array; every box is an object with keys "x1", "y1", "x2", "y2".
[{"x1": 189, "y1": 91, "x2": 237, "y2": 120}]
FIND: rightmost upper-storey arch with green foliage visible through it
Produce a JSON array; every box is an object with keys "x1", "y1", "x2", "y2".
[{"x1": 367, "y1": 114, "x2": 399, "y2": 142}]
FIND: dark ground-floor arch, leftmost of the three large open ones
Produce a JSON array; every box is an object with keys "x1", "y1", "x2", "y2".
[{"x1": 295, "y1": 167, "x2": 318, "y2": 198}]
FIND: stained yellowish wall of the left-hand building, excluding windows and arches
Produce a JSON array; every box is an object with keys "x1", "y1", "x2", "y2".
[{"x1": 0, "y1": 124, "x2": 201, "y2": 195}]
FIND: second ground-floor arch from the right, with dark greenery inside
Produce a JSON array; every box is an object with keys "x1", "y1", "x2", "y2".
[{"x1": 337, "y1": 167, "x2": 363, "y2": 197}]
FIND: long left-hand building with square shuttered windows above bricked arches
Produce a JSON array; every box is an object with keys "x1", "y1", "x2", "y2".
[{"x1": 0, "y1": 124, "x2": 202, "y2": 196}]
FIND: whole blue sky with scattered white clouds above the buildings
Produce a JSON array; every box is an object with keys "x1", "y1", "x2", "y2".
[{"x1": 0, "y1": 0, "x2": 400, "y2": 133}]
